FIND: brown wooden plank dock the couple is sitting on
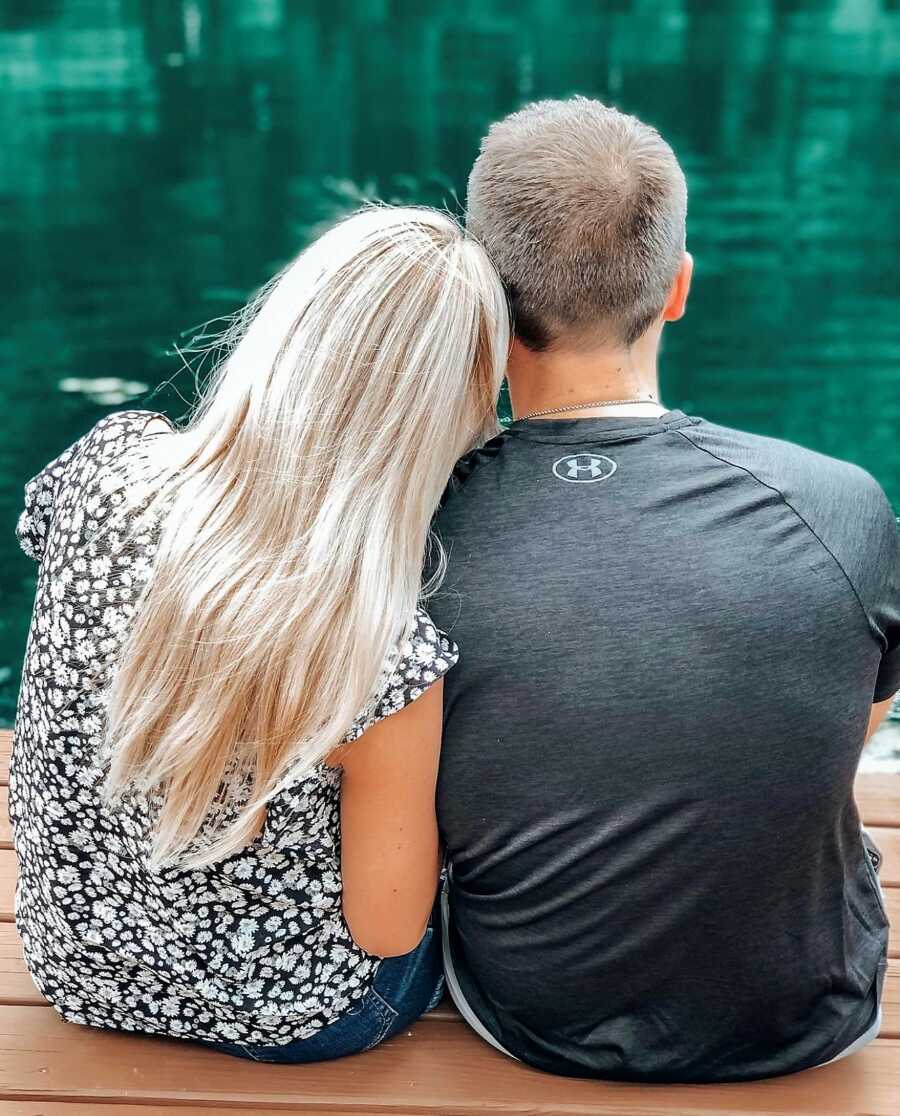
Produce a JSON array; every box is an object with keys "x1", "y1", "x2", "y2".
[{"x1": 0, "y1": 732, "x2": 900, "y2": 1116}]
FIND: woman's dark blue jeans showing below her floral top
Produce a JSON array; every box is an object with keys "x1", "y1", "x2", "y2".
[{"x1": 203, "y1": 925, "x2": 443, "y2": 1065}]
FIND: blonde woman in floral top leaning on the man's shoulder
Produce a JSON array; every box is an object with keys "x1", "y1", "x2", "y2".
[{"x1": 10, "y1": 208, "x2": 508, "y2": 1061}]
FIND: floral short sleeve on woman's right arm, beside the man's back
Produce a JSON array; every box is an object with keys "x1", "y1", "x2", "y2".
[{"x1": 346, "y1": 608, "x2": 459, "y2": 741}]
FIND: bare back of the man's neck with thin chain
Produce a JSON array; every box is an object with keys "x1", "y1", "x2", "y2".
[{"x1": 507, "y1": 330, "x2": 664, "y2": 419}]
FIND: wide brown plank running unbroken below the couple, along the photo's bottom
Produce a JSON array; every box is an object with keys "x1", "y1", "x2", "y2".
[{"x1": 0, "y1": 1007, "x2": 900, "y2": 1116}]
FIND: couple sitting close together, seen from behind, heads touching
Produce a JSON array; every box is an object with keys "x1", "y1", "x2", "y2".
[{"x1": 10, "y1": 98, "x2": 900, "y2": 1081}]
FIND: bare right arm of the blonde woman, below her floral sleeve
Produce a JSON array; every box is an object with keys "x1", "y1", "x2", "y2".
[{"x1": 329, "y1": 681, "x2": 443, "y2": 958}]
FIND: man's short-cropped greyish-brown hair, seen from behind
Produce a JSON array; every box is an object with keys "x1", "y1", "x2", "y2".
[{"x1": 466, "y1": 97, "x2": 687, "y2": 349}]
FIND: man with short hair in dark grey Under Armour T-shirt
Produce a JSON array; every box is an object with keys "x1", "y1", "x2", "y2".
[{"x1": 430, "y1": 98, "x2": 900, "y2": 1081}]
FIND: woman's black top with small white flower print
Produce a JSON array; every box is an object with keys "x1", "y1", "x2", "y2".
[{"x1": 10, "y1": 411, "x2": 457, "y2": 1043}]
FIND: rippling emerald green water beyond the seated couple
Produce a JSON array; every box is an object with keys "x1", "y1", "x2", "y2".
[{"x1": 0, "y1": 0, "x2": 900, "y2": 720}]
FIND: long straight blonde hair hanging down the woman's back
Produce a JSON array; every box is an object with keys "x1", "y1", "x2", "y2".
[{"x1": 105, "y1": 206, "x2": 508, "y2": 867}]
